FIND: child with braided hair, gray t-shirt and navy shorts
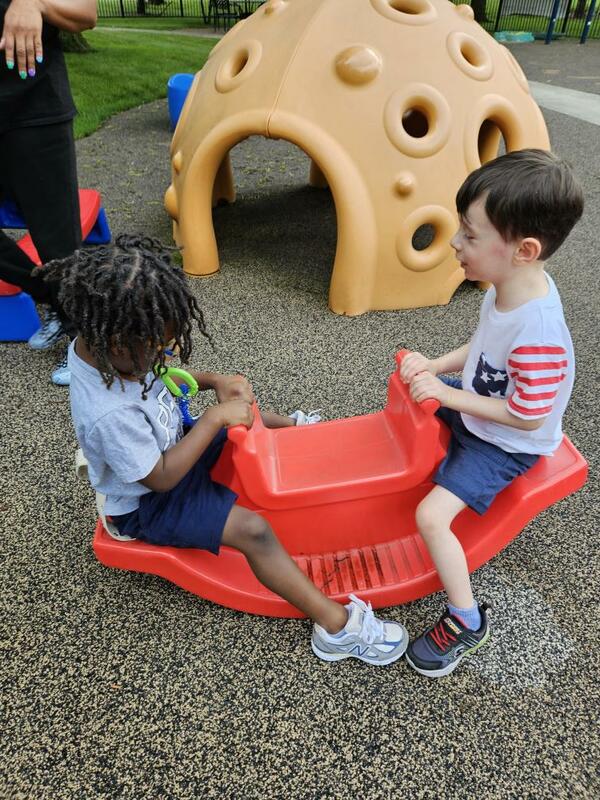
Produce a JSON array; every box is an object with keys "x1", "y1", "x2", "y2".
[{"x1": 42, "y1": 236, "x2": 408, "y2": 665}]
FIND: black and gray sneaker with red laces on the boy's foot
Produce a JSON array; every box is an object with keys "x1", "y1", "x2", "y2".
[{"x1": 406, "y1": 603, "x2": 491, "y2": 678}]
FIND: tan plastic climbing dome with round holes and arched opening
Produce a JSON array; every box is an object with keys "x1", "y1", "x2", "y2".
[{"x1": 165, "y1": 0, "x2": 549, "y2": 314}]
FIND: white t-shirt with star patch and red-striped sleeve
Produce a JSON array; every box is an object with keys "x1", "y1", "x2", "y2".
[{"x1": 461, "y1": 273, "x2": 575, "y2": 455}]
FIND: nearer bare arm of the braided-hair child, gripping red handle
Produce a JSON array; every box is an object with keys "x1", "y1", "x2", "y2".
[{"x1": 140, "y1": 400, "x2": 252, "y2": 492}]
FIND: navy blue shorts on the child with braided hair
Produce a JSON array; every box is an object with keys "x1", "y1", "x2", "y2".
[{"x1": 111, "y1": 430, "x2": 237, "y2": 555}]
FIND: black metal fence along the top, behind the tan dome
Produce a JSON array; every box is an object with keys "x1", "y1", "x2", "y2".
[{"x1": 98, "y1": 0, "x2": 600, "y2": 41}]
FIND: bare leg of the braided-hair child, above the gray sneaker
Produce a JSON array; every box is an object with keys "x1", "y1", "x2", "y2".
[{"x1": 221, "y1": 506, "x2": 348, "y2": 633}]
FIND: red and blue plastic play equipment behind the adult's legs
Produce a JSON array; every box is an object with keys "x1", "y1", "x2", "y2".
[{"x1": 0, "y1": 189, "x2": 111, "y2": 342}]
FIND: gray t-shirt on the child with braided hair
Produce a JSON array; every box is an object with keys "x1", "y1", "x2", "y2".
[{"x1": 68, "y1": 342, "x2": 183, "y2": 514}]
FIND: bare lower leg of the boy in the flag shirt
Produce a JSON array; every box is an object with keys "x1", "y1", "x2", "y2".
[{"x1": 417, "y1": 486, "x2": 474, "y2": 608}]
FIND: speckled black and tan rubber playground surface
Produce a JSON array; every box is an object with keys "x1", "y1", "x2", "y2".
[{"x1": 0, "y1": 42, "x2": 600, "y2": 800}]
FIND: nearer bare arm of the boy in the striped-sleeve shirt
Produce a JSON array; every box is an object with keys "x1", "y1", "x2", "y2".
[{"x1": 410, "y1": 372, "x2": 544, "y2": 431}]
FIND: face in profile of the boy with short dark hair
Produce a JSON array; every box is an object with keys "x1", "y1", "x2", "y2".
[{"x1": 450, "y1": 197, "x2": 519, "y2": 284}]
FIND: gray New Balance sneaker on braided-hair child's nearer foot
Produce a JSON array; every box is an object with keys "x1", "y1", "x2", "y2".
[{"x1": 311, "y1": 594, "x2": 408, "y2": 666}]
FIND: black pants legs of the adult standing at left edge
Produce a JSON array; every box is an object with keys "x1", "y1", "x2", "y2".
[{"x1": 0, "y1": 121, "x2": 81, "y2": 320}]
